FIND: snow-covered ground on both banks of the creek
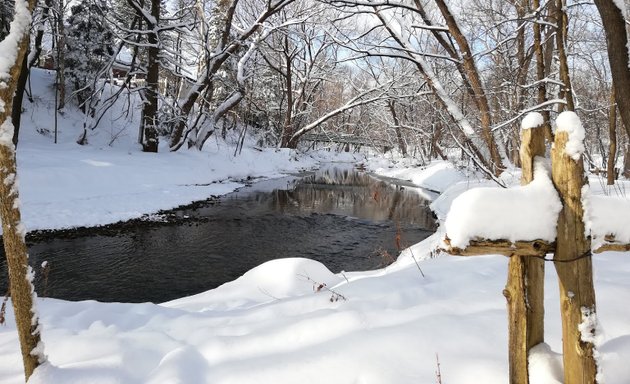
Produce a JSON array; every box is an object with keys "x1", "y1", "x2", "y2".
[{"x1": 0, "y1": 72, "x2": 630, "y2": 384}]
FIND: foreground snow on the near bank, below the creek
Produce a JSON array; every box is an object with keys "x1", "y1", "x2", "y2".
[{"x1": 0, "y1": 244, "x2": 630, "y2": 384}]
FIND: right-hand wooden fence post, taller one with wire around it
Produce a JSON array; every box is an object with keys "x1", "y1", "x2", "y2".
[{"x1": 551, "y1": 112, "x2": 597, "y2": 384}]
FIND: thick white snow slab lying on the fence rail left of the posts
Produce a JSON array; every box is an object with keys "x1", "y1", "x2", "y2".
[{"x1": 444, "y1": 159, "x2": 562, "y2": 248}]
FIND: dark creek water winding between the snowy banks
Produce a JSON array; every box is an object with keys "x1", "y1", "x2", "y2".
[{"x1": 0, "y1": 168, "x2": 435, "y2": 302}]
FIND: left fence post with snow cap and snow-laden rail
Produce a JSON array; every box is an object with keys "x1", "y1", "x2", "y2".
[{"x1": 444, "y1": 109, "x2": 561, "y2": 384}]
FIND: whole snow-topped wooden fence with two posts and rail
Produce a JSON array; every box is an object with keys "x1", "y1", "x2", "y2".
[{"x1": 441, "y1": 112, "x2": 630, "y2": 384}]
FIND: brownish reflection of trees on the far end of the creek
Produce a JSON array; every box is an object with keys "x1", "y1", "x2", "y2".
[{"x1": 260, "y1": 169, "x2": 435, "y2": 229}]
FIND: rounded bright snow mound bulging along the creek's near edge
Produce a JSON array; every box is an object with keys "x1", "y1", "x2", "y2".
[{"x1": 162, "y1": 257, "x2": 344, "y2": 312}]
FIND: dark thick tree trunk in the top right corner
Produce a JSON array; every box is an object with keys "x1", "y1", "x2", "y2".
[{"x1": 595, "y1": 0, "x2": 630, "y2": 141}]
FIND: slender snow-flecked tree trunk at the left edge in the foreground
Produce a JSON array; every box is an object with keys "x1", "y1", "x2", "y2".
[{"x1": 0, "y1": 0, "x2": 44, "y2": 380}]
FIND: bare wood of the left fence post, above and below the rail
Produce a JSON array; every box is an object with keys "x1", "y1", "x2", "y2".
[{"x1": 503, "y1": 121, "x2": 545, "y2": 384}]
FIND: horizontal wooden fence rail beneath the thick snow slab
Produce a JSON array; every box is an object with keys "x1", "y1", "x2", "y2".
[{"x1": 441, "y1": 236, "x2": 556, "y2": 257}]
